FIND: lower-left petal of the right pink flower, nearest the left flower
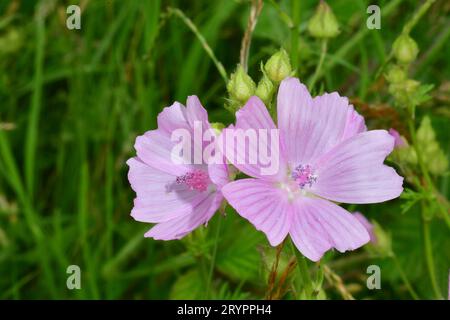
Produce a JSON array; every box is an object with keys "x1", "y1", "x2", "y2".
[{"x1": 222, "y1": 179, "x2": 291, "y2": 246}]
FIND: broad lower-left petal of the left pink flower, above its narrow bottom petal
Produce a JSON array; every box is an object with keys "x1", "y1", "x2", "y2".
[{"x1": 127, "y1": 158, "x2": 207, "y2": 223}]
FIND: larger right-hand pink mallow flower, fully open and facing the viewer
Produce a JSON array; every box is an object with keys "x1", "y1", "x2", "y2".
[{"x1": 222, "y1": 78, "x2": 403, "y2": 261}]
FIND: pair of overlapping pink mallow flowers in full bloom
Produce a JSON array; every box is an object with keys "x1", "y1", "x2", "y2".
[{"x1": 127, "y1": 78, "x2": 403, "y2": 261}]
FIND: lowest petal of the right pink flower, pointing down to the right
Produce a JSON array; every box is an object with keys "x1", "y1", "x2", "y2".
[{"x1": 289, "y1": 197, "x2": 369, "y2": 261}]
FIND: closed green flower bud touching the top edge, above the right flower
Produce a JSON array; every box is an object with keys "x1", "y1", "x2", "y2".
[{"x1": 308, "y1": 1, "x2": 339, "y2": 38}]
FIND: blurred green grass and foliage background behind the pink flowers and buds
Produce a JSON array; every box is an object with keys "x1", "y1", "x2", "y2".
[{"x1": 0, "y1": 0, "x2": 450, "y2": 299}]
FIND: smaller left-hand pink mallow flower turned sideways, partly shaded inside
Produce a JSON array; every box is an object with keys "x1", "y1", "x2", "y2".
[{"x1": 127, "y1": 96, "x2": 228, "y2": 240}]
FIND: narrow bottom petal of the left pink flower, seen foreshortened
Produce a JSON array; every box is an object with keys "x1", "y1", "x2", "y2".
[{"x1": 144, "y1": 193, "x2": 223, "y2": 240}]
